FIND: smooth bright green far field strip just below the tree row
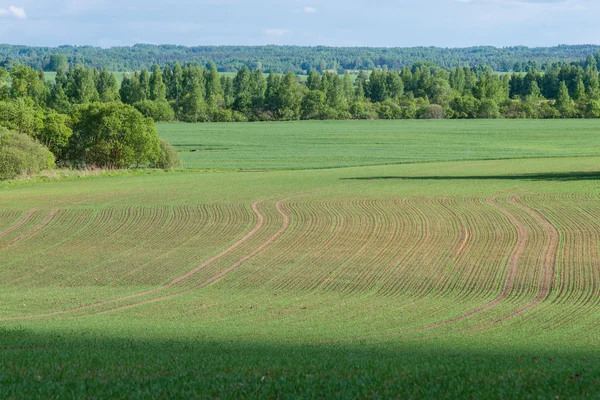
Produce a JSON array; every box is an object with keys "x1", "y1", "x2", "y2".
[{"x1": 158, "y1": 120, "x2": 600, "y2": 170}]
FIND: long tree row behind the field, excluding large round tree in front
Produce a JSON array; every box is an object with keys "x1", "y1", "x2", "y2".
[{"x1": 7, "y1": 56, "x2": 600, "y2": 123}]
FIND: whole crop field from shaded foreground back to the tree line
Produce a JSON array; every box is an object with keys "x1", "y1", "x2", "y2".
[{"x1": 0, "y1": 121, "x2": 600, "y2": 399}]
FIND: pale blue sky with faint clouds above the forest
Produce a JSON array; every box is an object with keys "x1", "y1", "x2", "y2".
[{"x1": 0, "y1": 0, "x2": 600, "y2": 47}]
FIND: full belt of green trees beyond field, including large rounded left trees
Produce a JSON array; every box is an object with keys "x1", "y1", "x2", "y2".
[{"x1": 0, "y1": 48, "x2": 600, "y2": 178}]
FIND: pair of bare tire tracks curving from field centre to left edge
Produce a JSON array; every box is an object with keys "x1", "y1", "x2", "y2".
[{"x1": 0, "y1": 196, "x2": 298, "y2": 321}]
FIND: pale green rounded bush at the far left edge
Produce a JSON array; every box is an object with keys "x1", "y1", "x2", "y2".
[{"x1": 0, "y1": 128, "x2": 56, "y2": 179}]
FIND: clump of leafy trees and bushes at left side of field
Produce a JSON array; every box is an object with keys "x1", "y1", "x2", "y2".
[{"x1": 0, "y1": 65, "x2": 179, "y2": 179}]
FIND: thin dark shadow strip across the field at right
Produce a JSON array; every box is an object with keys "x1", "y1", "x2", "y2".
[{"x1": 341, "y1": 171, "x2": 600, "y2": 182}]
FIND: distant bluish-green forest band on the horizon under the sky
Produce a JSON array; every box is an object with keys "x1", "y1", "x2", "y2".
[{"x1": 0, "y1": 44, "x2": 600, "y2": 74}]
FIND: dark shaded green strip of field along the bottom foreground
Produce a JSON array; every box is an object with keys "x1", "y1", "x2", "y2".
[{"x1": 0, "y1": 328, "x2": 600, "y2": 399}]
